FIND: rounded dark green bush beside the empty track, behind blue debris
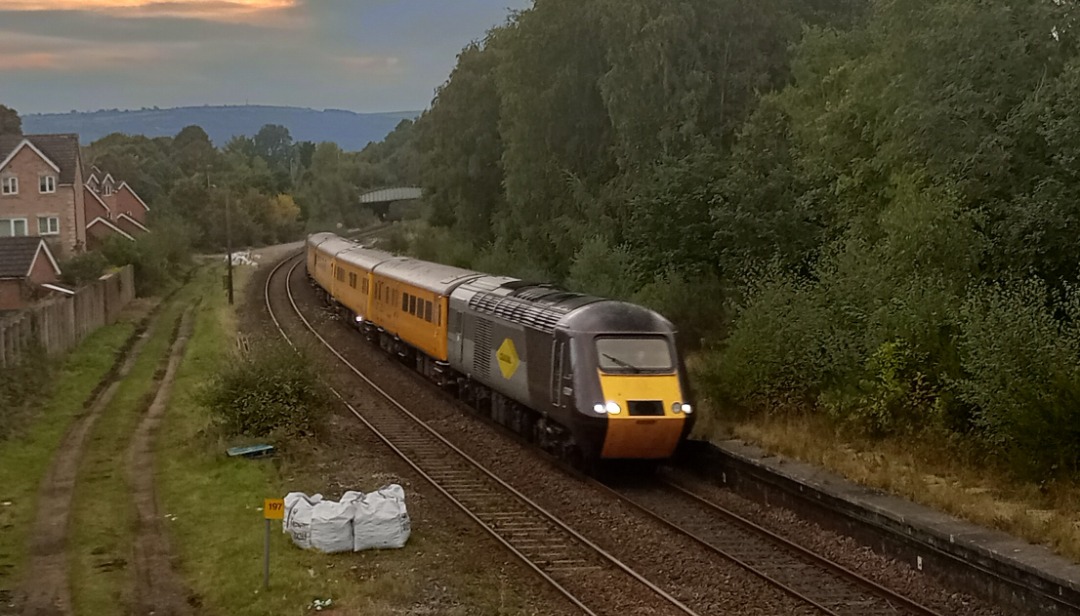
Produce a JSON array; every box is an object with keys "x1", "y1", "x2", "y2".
[{"x1": 203, "y1": 342, "x2": 330, "y2": 439}]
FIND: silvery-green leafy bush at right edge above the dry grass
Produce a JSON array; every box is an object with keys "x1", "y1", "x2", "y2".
[{"x1": 957, "y1": 280, "x2": 1080, "y2": 479}]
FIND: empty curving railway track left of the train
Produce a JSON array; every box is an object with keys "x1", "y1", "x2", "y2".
[{"x1": 264, "y1": 251, "x2": 697, "y2": 616}]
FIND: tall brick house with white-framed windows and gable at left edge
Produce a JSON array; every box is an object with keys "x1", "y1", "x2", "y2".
[{"x1": 0, "y1": 134, "x2": 86, "y2": 258}]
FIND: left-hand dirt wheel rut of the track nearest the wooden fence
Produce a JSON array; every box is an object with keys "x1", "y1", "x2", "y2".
[{"x1": 16, "y1": 314, "x2": 156, "y2": 616}]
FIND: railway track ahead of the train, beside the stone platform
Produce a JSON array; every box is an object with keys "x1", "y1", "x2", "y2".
[{"x1": 594, "y1": 479, "x2": 940, "y2": 616}]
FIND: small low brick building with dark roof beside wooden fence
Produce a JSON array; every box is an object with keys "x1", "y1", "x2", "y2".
[{"x1": 0, "y1": 236, "x2": 63, "y2": 311}]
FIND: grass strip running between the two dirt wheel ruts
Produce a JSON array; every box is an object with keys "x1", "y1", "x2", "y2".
[{"x1": 70, "y1": 290, "x2": 190, "y2": 615}]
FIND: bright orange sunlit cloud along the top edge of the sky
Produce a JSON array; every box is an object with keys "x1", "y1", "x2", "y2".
[{"x1": 3, "y1": 0, "x2": 299, "y2": 22}]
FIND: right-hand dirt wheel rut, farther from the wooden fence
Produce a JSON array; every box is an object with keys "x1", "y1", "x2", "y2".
[{"x1": 127, "y1": 308, "x2": 192, "y2": 616}]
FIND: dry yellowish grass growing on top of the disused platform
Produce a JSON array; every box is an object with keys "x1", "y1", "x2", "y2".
[{"x1": 699, "y1": 413, "x2": 1080, "y2": 562}]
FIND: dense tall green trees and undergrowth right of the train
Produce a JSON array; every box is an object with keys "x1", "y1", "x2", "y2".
[{"x1": 380, "y1": 0, "x2": 1080, "y2": 477}]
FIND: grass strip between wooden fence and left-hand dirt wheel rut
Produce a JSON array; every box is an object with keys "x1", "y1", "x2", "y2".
[{"x1": 0, "y1": 312, "x2": 140, "y2": 589}]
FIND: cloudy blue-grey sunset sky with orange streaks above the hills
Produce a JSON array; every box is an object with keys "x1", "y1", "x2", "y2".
[{"x1": 0, "y1": 0, "x2": 531, "y2": 115}]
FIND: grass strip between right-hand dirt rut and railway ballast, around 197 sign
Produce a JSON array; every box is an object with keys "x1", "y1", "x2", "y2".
[{"x1": 156, "y1": 268, "x2": 384, "y2": 616}]
